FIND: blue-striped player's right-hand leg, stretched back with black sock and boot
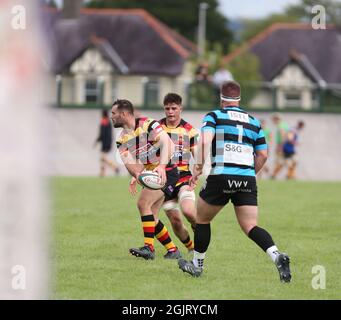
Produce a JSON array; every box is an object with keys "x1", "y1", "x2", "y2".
[{"x1": 234, "y1": 205, "x2": 291, "y2": 282}]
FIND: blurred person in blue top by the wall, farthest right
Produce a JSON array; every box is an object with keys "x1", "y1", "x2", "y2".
[{"x1": 283, "y1": 120, "x2": 305, "y2": 179}]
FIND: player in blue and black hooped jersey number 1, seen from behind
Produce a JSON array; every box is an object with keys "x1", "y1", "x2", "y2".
[{"x1": 178, "y1": 81, "x2": 291, "y2": 282}]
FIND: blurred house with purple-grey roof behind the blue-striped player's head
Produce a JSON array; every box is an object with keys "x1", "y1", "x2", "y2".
[{"x1": 224, "y1": 23, "x2": 341, "y2": 110}]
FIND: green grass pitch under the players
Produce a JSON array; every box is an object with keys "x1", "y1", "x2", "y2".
[{"x1": 51, "y1": 178, "x2": 341, "y2": 300}]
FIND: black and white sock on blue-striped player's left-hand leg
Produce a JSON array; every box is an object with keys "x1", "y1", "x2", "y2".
[{"x1": 193, "y1": 223, "x2": 211, "y2": 268}]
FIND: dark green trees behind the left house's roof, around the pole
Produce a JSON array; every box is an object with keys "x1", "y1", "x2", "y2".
[{"x1": 87, "y1": 0, "x2": 232, "y2": 52}]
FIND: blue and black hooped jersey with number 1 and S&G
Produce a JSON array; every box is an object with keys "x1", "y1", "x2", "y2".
[{"x1": 201, "y1": 107, "x2": 267, "y2": 176}]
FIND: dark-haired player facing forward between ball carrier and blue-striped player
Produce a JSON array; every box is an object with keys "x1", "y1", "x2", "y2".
[{"x1": 129, "y1": 93, "x2": 199, "y2": 251}]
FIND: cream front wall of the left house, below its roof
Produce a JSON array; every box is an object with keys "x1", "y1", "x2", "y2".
[{"x1": 51, "y1": 48, "x2": 193, "y2": 106}]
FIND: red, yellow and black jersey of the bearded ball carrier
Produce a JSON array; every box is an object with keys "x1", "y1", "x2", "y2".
[{"x1": 116, "y1": 117, "x2": 163, "y2": 170}]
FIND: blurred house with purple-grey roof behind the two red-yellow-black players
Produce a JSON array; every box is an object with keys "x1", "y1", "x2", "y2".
[{"x1": 46, "y1": 8, "x2": 196, "y2": 106}]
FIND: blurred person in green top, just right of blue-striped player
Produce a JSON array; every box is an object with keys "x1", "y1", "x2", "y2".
[{"x1": 271, "y1": 113, "x2": 289, "y2": 179}]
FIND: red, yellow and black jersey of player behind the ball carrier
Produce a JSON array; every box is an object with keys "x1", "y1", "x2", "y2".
[{"x1": 159, "y1": 118, "x2": 199, "y2": 183}]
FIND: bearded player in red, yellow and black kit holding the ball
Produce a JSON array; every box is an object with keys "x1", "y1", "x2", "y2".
[{"x1": 111, "y1": 100, "x2": 180, "y2": 260}]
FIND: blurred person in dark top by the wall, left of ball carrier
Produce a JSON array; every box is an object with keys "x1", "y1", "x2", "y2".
[{"x1": 94, "y1": 110, "x2": 119, "y2": 177}]
